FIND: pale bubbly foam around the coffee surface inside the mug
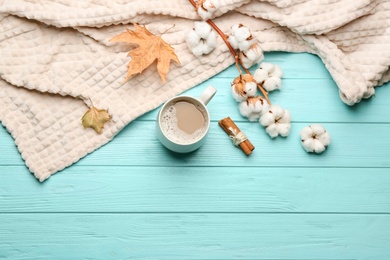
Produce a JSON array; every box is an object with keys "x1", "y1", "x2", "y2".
[{"x1": 160, "y1": 100, "x2": 208, "y2": 144}]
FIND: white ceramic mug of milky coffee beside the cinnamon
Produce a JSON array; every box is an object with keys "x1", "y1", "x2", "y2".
[{"x1": 156, "y1": 86, "x2": 217, "y2": 153}]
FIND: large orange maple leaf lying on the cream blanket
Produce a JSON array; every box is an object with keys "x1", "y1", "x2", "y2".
[{"x1": 110, "y1": 24, "x2": 180, "y2": 83}]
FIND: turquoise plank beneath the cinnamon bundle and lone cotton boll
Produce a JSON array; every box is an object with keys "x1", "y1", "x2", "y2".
[{"x1": 0, "y1": 121, "x2": 390, "y2": 168}]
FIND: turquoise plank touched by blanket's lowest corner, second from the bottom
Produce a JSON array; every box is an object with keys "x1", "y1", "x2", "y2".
[{"x1": 0, "y1": 166, "x2": 390, "y2": 214}]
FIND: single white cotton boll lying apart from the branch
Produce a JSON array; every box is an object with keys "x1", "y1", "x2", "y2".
[{"x1": 300, "y1": 124, "x2": 330, "y2": 153}]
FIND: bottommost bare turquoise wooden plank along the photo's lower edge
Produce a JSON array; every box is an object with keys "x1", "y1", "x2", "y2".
[{"x1": 0, "y1": 213, "x2": 390, "y2": 260}]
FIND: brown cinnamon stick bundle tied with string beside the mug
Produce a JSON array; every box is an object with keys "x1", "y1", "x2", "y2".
[{"x1": 218, "y1": 117, "x2": 255, "y2": 155}]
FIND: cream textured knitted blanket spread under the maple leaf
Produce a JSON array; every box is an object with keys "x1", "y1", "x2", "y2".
[{"x1": 0, "y1": 0, "x2": 390, "y2": 181}]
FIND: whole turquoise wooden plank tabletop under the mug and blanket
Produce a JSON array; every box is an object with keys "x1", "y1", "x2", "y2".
[{"x1": 0, "y1": 52, "x2": 390, "y2": 259}]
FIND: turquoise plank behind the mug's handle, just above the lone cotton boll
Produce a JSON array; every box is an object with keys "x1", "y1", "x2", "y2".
[{"x1": 138, "y1": 76, "x2": 390, "y2": 123}]
